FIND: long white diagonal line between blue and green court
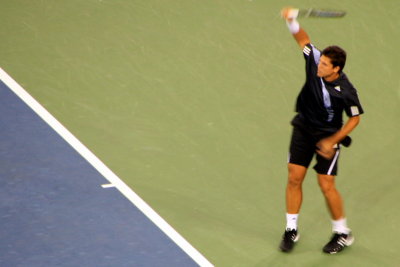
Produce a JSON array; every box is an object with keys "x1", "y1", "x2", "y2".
[{"x1": 0, "y1": 68, "x2": 214, "y2": 267}]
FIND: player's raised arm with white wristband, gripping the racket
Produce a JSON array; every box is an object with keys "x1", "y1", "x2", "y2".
[{"x1": 281, "y1": 7, "x2": 311, "y2": 49}]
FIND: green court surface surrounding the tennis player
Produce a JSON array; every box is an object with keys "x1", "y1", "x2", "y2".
[{"x1": 0, "y1": 0, "x2": 400, "y2": 267}]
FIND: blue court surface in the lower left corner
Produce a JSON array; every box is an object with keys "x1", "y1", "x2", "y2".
[{"x1": 0, "y1": 72, "x2": 212, "y2": 267}]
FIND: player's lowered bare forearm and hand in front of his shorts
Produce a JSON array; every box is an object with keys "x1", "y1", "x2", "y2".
[{"x1": 317, "y1": 115, "x2": 360, "y2": 159}]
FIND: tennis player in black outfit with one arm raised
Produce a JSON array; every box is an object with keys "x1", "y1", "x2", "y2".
[{"x1": 280, "y1": 5, "x2": 363, "y2": 254}]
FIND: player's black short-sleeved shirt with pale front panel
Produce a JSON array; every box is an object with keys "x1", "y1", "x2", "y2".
[{"x1": 292, "y1": 44, "x2": 364, "y2": 132}]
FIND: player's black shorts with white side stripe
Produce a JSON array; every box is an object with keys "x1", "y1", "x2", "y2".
[{"x1": 288, "y1": 126, "x2": 340, "y2": 175}]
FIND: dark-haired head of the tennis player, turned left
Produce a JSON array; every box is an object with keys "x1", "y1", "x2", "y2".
[{"x1": 318, "y1": 46, "x2": 346, "y2": 81}]
